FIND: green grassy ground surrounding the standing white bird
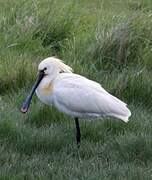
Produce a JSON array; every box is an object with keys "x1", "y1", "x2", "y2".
[{"x1": 0, "y1": 0, "x2": 152, "y2": 180}]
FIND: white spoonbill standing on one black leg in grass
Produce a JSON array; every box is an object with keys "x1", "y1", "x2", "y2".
[{"x1": 21, "y1": 57, "x2": 131, "y2": 145}]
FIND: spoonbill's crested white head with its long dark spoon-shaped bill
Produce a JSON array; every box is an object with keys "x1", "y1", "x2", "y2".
[{"x1": 21, "y1": 57, "x2": 72, "y2": 113}]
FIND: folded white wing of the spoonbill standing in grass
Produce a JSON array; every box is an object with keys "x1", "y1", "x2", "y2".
[{"x1": 54, "y1": 74, "x2": 129, "y2": 119}]
